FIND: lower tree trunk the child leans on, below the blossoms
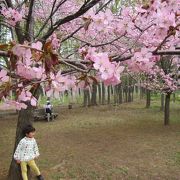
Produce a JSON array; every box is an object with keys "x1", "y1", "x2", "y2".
[{"x1": 8, "y1": 105, "x2": 33, "y2": 180}]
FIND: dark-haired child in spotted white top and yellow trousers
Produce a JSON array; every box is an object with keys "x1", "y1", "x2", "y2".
[{"x1": 14, "y1": 125, "x2": 44, "y2": 180}]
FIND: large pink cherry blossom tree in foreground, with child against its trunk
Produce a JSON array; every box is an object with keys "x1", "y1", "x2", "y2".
[{"x1": 0, "y1": 0, "x2": 180, "y2": 180}]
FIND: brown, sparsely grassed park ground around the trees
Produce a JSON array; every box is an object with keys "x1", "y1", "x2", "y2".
[{"x1": 0, "y1": 101, "x2": 180, "y2": 180}]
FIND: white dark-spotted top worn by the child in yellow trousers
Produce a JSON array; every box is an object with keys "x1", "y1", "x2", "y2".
[{"x1": 14, "y1": 137, "x2": 39, "y2": 161}]
